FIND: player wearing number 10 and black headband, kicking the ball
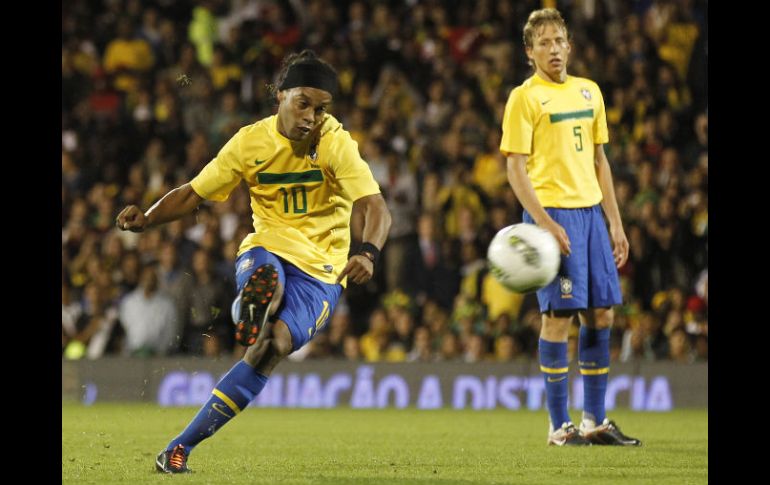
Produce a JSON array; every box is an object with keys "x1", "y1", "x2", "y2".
[{"x1": 116, "y1": 50, "x2": 391, "y2": 473}]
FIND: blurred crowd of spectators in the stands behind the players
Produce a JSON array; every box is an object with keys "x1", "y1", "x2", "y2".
[{"x1": 62, "y1": 0, "x2": 708, "y2": 362}]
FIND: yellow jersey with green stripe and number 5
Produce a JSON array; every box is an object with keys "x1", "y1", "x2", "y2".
[{"x1": 500, "y1": 74, "x2": 609, "y2": 209}]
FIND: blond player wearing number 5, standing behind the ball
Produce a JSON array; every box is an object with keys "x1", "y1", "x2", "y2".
[{"x1": 500, "y1": 8, "x2": 641, "y2": 446}]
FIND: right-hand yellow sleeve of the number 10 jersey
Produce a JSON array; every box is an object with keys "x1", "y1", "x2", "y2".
[{"x1": 329, "y1": 128, "x2": 380, "y2": 201}]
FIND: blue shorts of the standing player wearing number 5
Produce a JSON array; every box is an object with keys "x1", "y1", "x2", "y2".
[{"x1": 524, "y1": 205, "x2": 623, "y2": 312}]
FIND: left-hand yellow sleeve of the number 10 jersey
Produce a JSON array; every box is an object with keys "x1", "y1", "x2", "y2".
[{"x1": 190, "y1": 129, "x2": 243, "y2": 202}]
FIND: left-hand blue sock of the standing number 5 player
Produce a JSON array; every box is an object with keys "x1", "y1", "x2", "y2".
[{"x1": 539, "y1": 339, "x2": 570, "y2": 429}]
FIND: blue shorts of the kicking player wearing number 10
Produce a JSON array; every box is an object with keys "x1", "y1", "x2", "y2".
[{"x1": 232, "y1": 247, "x2": 342, "y2": 351}]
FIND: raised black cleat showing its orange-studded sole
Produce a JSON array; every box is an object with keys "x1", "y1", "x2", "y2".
[{"x1": 235, "y1": 264, "x2": 278, "y2": 347}]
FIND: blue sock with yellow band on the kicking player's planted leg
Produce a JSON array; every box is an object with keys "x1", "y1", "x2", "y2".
[{"x1": 166, "y1": 360, "x2": 267, "y2": 454}]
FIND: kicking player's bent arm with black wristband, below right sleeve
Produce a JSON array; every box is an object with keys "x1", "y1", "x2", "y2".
[{"x1": 337, "y1": 194, "x2": 391, "y2": 285}]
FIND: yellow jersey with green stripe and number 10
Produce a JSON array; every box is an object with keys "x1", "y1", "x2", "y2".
[{"x1": 190, "y1": 115, "x2": 380, "y2": 283}]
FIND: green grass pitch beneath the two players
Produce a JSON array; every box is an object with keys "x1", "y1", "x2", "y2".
[{"x1": 62, "y1": 403, "x2": 708, "y2": 485}]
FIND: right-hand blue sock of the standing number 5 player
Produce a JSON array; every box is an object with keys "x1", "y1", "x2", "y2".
[{"x1": 578, "y1": 325, "x2": 610, "y2": 425}]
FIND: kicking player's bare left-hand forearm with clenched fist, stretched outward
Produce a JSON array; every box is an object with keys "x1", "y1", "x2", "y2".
[{"x1": 115, "y1": 183, "x2": 203, "y2": 232}]
